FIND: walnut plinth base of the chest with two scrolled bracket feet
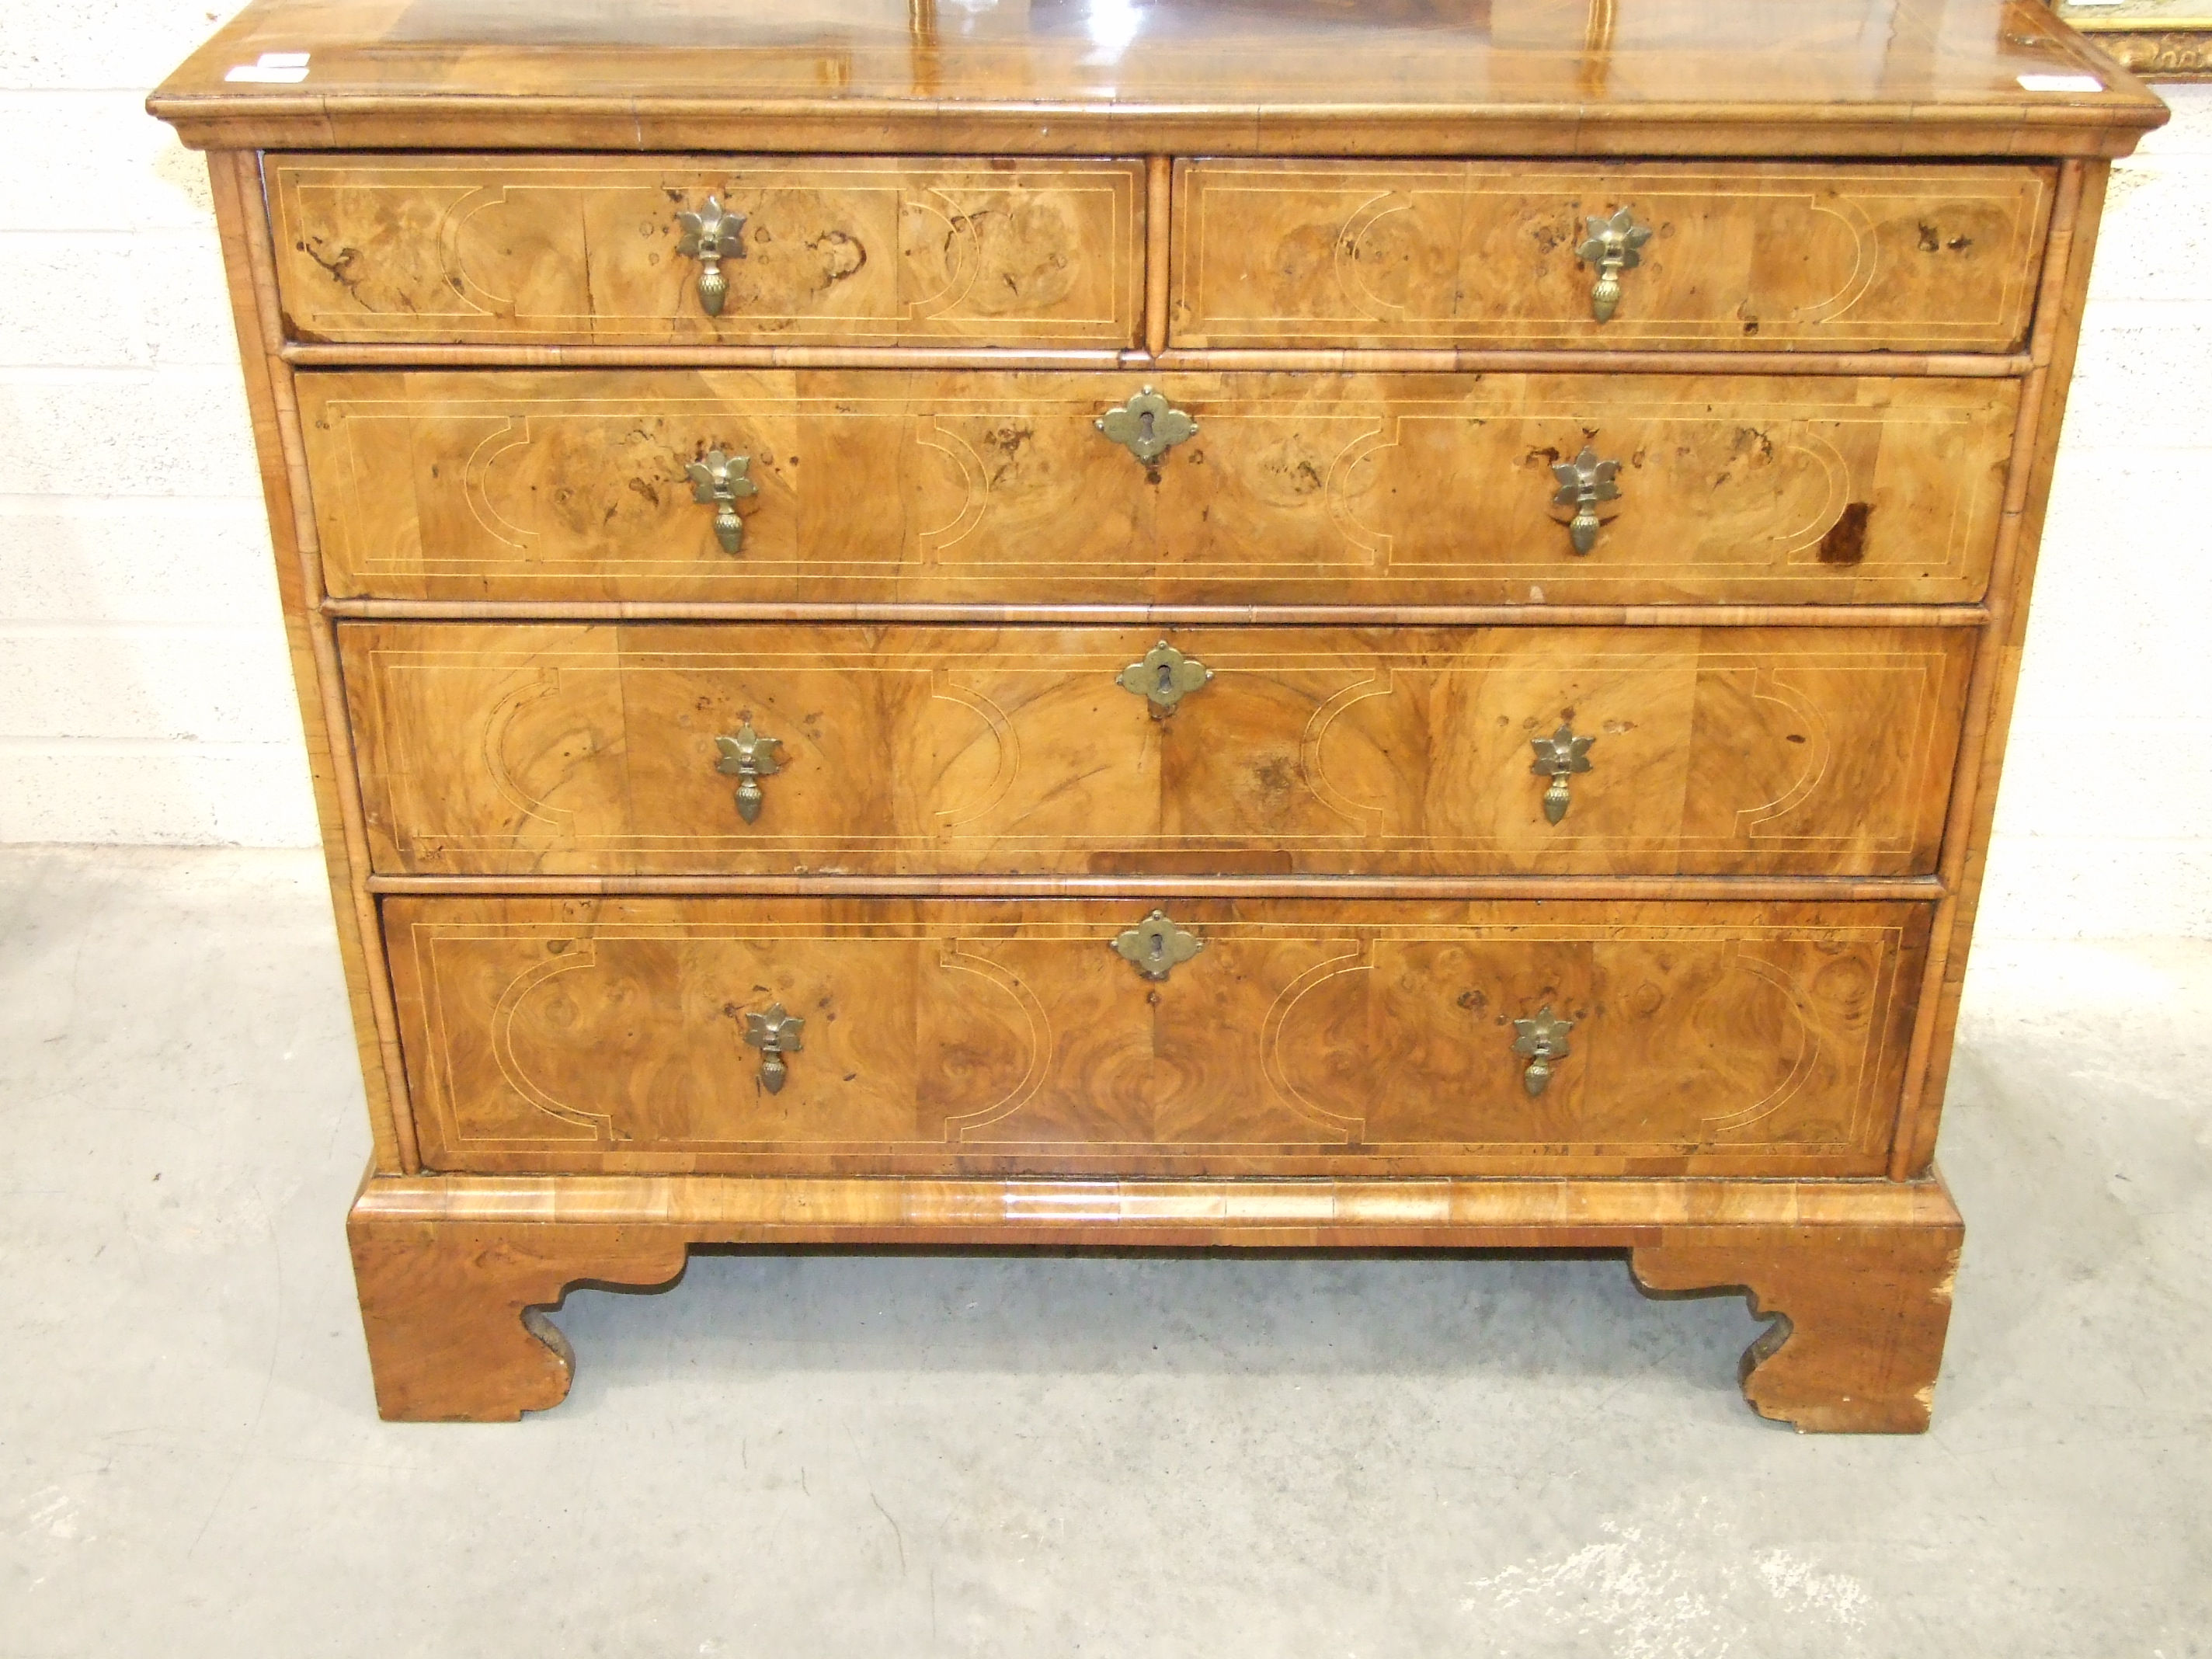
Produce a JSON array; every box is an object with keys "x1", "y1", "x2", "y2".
[{"x1": 347, "y1": 1177, "x2": 1962, "y2": 1431}]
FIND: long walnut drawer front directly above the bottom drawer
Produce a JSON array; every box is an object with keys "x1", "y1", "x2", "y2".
[{"x1": 341, "y1": 621, "x2": 1973, "y2": 876}]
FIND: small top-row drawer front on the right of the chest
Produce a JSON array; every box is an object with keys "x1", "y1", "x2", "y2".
[{"x1": 1170, "y1": 162, "x2": 2055, "y2": 352}]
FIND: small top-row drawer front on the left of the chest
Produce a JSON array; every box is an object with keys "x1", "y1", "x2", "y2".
[{"x1": 266, "y1": 155, "x2": 1143, "y2": 347}]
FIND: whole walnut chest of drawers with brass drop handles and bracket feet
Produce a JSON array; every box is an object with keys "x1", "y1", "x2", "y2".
[{"x1": 153, "y1": 0, "x2": 2163, "y2": 1429}]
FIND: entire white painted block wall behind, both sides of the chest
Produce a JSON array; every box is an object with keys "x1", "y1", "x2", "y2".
[{"x1": 0, "y1": 0, "x2": 2212, "y2": 936}]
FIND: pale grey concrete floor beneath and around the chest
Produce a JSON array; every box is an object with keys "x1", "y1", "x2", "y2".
[{"x1": 0, "y1": 850, "x2": 2212, "y2": 1659}]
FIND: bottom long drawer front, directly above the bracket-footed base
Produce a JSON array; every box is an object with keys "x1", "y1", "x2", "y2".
[{"x1": 383, "y1": 898, "x2": 1927, "y2": 1174}]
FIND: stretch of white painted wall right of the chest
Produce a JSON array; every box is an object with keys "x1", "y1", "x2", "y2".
[{"x1": 1982, "y1": 86, "x2": 2212, "y2": 938}]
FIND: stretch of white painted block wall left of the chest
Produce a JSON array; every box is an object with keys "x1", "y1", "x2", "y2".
[{"x1": 0, "y1": 0, "x2": 314, "y2": 845}]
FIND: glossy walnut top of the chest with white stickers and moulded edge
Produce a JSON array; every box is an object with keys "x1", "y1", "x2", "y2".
[{"x1": 148, "y1": 0, "x2": 2165, "y2": 155}]
